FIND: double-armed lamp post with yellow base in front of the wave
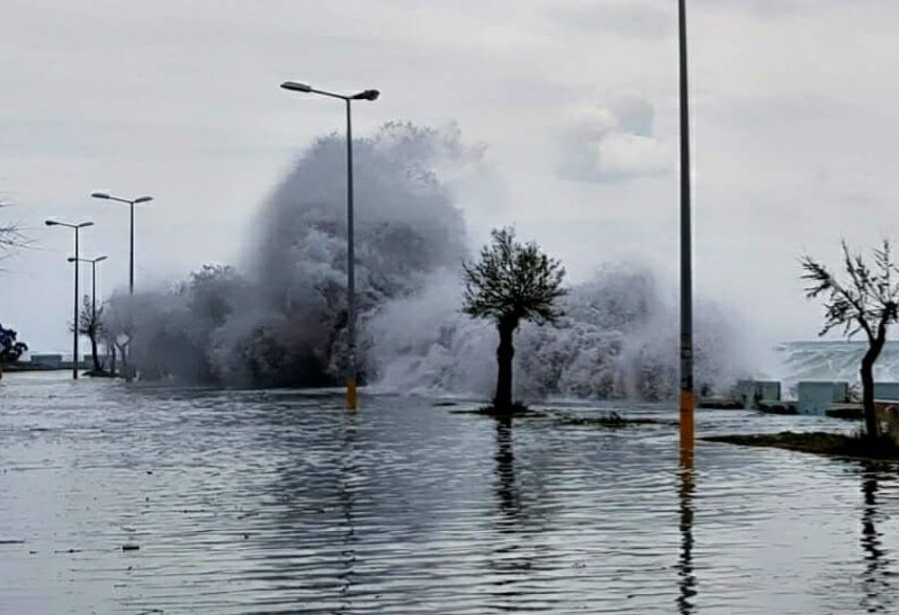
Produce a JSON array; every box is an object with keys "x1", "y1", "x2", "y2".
[{"x1": 281, "y1": 81, "x2": 380, "y2": 412}]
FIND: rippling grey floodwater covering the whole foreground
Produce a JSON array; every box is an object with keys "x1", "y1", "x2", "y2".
[{"x1": 0, "y1": 374, "x2": 899, "y2": 615}]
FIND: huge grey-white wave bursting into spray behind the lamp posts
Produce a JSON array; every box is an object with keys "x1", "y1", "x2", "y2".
[{"x1": 108, "y1": 123, "x2": 746, "y2": 399}]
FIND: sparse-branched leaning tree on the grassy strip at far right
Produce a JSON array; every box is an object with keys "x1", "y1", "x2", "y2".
[{"x1": 800, "y1": 240, "x2": 899, "y2": 439}]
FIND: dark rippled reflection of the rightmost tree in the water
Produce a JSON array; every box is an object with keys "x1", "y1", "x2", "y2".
[{"x1": 861, "y1": 464, "x2": 895, "y2": 613}]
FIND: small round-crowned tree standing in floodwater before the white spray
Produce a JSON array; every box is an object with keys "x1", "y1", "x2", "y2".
[{"x1": 462, "y1": 228, "x2": 566, "y2": 414}]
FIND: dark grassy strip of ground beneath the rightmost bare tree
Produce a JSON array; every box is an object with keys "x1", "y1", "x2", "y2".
[{"x1": 700, "y1": 431, "x2": 899, "y2": 461}]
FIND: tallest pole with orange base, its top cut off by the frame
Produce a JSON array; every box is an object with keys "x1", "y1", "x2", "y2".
[{"x1": 678, "y1": 0, "x2": 695, "y2": 466}]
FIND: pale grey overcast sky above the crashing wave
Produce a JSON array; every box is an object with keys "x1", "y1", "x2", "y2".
[{"x1": 0, "y1": 0, "x2": 899, "y2": 351}]
